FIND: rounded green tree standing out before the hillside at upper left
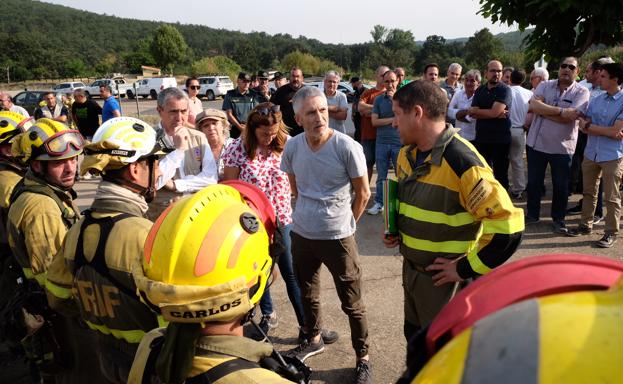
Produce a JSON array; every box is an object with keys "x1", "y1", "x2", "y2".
[{"x1": 151, "y1": 24, "x2": 188, "y2": 72}]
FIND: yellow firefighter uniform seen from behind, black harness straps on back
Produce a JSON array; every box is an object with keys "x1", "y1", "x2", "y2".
[{"x1": 46, "y1": 181, "x2": 162, "y2": 383}]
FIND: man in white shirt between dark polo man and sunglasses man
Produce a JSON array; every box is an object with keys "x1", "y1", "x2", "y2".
[{"x1": 508, "y1": 69, "x2": 532, "y2": 199}]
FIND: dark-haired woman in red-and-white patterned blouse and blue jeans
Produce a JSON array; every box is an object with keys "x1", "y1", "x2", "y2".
[{"x1": 223, "y1": 103, "x2": 304, "y2": 340}]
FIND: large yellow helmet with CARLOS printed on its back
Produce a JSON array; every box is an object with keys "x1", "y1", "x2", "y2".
[{"x1": 133, "y1": 184, "x2": 272, "y2": 323}]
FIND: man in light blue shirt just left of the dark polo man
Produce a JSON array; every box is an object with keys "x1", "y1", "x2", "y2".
[{"x1": 446, "y1": 69, "x2": 482, "y2": 142}]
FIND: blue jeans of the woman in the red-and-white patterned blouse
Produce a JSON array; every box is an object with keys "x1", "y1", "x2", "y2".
[{"x1": 260, "y1": 224, "x2": 305, "y2": 327}]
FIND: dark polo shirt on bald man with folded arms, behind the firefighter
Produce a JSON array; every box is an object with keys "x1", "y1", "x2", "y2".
[{"x1": 472, "y1": 82, "x2": 513, "y2": 143}]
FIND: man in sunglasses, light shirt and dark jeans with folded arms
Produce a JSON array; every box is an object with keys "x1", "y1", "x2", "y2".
[{"x1": 525, "y1": 57, "x2": 589, "y2": 234}]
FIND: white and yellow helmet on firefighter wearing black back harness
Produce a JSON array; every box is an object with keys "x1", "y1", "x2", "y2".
[{"x1": 81, "y1": 116, "x2": 156, "y2": 174}]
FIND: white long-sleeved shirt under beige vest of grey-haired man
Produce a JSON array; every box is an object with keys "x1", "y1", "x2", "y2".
[{"x1": 156, "y1": 124, "x2": 218, "y2": 193}]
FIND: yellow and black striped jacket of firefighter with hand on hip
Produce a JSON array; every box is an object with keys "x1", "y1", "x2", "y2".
[{"x1": 396, "y1": 125, "x2": 524, "y2": 278}]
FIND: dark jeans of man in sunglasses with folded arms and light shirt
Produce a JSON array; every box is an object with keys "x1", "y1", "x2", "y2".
[{"x1": 526, "y1": 146, "x2": 573, "y2": 223}]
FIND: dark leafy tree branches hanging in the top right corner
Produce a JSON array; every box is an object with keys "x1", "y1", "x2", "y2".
[{"x1": 478, "y1": 0, "x2": 623, "y2": 59}]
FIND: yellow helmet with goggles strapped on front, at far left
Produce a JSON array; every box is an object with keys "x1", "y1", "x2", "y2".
[{"x1": 11, "y1": 118, "x2": 84, "y2": 163}]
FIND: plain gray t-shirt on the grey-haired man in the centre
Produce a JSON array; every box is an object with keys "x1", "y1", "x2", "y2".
[{"x1": 281, "y1": 130, "x2": 367, "y2": 240}]
